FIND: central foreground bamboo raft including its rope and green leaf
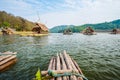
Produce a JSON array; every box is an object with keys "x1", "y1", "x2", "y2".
[{"x1": 33, "y1": 50, "x2": 88, "y2": 80}]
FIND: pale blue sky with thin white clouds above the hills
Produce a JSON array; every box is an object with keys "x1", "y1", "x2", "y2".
[{"x1": 0, "y1": 0, "x2": 120, "y2": 28}]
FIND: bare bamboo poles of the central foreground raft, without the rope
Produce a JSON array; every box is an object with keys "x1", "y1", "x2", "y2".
[{"x1": 41, "y1": 51, "x2": 87, "y2": 80}]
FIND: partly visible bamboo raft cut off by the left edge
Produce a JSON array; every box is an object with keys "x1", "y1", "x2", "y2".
[{"x1": 0, "y1": 51, "x2": 17, "y2": 72}]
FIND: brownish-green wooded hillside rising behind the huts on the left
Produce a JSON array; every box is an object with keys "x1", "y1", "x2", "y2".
[{"x1": 0, "y1": 11, "x2": 34, "y2": 31}]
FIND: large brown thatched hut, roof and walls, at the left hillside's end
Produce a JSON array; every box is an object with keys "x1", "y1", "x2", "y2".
[{"x1": 32, "y1": 23, "x2": 48, "y2": 34}]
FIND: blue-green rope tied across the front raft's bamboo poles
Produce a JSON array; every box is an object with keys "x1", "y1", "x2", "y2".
[{"x1": 48, "y1": 70, "x2": 88, "y2": 80}]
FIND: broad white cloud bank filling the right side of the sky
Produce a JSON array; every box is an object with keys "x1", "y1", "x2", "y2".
[{"x1": 39, "y1": 0, "x2": 120, "y2": 27}]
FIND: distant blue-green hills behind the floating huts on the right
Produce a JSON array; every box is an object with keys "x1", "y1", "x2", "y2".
[{"x1": 50, "y1": 19, "x2": 120, "y2": 33}]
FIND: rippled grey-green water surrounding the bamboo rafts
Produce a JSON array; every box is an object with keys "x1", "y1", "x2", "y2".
[{"x1": 0, "y1": 33, "x2": 120, "y2": 80}]
